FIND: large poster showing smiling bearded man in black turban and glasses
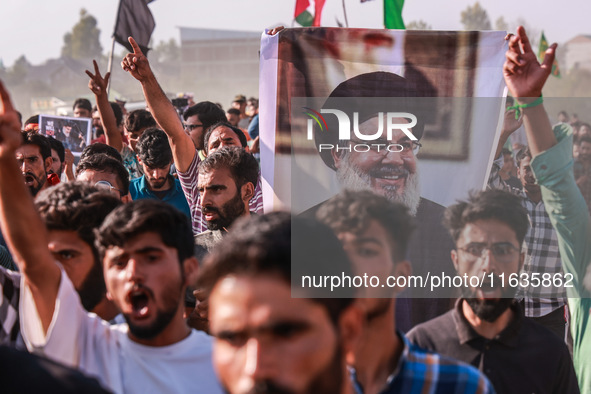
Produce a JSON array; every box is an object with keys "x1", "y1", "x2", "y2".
[{"x1": 260, "y1": 28, "x2": 506, "y2": 331}]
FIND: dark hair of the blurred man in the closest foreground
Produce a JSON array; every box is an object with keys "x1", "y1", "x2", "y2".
[{"x1": 198, "y1": 212, "x2": 354, "y2": 324}]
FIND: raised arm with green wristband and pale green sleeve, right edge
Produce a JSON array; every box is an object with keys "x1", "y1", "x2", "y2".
[{"x1": 503, "y1": 26, "x2": 591, "y2": 394}]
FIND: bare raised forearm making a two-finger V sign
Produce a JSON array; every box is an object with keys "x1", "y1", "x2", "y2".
[{"x1": 86, "y1": 60, "x2": 123, "y2": 152}]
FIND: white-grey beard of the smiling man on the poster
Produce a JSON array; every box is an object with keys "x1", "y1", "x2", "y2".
[{"x1": 336, "y1": 153, "x2": 421, "y2": 216}]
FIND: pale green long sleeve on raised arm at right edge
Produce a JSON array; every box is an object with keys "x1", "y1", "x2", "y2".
[{"x1": 531, "y1": 123, "x2": 591, "y2": 394}]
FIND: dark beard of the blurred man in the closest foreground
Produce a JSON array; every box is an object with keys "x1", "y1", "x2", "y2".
[{"x1": 225, "y1": 343, "x2": 344, "y2": 394}]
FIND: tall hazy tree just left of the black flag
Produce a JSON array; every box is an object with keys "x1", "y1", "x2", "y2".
[{"x1": 62, "y1": 8, "x2": 103, "y2": 59}]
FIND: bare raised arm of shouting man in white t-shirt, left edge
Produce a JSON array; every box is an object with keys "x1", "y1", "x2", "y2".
[{"x1": 0, "y1": 81, "x2": 61, "y2": 332}]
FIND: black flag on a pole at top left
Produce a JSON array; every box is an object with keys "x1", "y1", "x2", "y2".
[{"x1": 113, "y1": 0, "x2": 156, "y2": 54}]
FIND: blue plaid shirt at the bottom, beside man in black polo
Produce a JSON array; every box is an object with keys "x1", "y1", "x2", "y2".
[{"x1": 351, "y1": 332, "x2": 495, "y2": 394}]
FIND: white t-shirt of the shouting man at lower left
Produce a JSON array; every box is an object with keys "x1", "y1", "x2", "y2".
[{"x1": 20, "y1": 271, "x2": 223, "y2": 394}]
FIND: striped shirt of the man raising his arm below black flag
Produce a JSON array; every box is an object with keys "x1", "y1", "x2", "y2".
[{"x1": 177, "y1": 151, "x2": 263, "y2": 235}]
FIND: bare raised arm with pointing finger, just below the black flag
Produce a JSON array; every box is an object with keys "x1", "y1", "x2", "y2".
[{"x1": 121, "y1": 37, "x2": 197, "y2": 172}]
